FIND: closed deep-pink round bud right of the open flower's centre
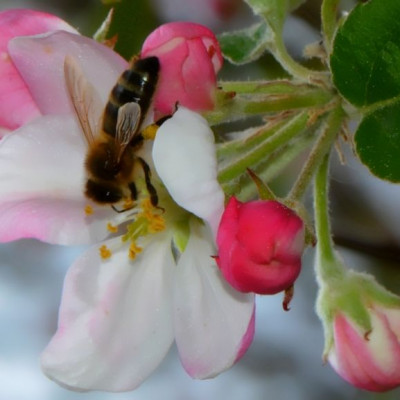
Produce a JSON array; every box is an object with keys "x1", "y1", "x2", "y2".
[{"x1": 217, "y1": 197, "x2": 304, "y2": 294}]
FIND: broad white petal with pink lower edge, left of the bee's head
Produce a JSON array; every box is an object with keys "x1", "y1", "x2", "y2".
[{"x1": 0, "y1": 116, "x2": 113, "y2": 244}]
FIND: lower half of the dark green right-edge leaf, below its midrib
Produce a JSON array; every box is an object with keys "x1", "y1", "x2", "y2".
[{"x1": 355, "y1": 101, "x2": 400, "y2": 182}]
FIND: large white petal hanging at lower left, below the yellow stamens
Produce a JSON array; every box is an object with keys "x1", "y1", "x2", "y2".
[{"x1": 42, "y1": 236, "x2": 177, "y2": 391}]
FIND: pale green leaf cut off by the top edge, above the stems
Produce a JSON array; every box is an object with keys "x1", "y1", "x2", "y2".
[{"x1": 245, "y1": 0, "x2": 305, "y2": 32}]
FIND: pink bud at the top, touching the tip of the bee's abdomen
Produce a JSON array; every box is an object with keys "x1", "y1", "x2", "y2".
[{"x1": 141, "y1": 22, "x2": 222, "y2": 114}]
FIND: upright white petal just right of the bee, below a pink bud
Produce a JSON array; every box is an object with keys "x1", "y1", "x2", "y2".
[{"x1": 153, "y1": 107, "x2": 224, "y2": 233}]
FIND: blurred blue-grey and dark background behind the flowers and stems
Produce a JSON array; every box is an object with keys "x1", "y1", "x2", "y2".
[{"x1": 0, "y1": 0, "x2": 400, "y2": 400}]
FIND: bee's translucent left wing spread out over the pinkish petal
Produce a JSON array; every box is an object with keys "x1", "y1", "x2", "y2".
[{"x1": 64, "y1": 55, "x2": 104, "y2": 145}]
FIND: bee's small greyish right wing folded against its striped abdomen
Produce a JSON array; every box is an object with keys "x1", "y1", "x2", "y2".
[{"x1": 115, "y1": 102, "x2": 142, "y2": 157}]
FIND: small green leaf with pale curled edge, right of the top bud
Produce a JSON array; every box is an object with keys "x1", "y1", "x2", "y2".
[{"x1": 218, "y1": 21, "x2": 272, "y2": 65}]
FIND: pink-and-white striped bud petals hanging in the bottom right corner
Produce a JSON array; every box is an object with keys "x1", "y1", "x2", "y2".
[{"x1": 328, "y1": 307, "x2": 400, "y2": 392}]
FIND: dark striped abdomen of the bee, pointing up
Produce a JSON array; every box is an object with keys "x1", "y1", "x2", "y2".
[{"x1": 103, "y1": 57, "x2": 160, "y2": 137}]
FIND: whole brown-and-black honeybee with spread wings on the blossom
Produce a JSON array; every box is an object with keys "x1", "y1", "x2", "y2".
[{"x1": 64, "y1": 56, "x2": 160, "y2": 206}]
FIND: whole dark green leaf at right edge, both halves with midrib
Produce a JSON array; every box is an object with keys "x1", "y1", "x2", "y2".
[{"x1": 330, "y1": 0, "x2": 400, "y2": 182}]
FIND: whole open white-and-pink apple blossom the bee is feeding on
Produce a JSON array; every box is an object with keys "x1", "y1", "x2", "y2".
[{"x1": 0, "y1": 10, "x2": 254, "y2": 391}]
